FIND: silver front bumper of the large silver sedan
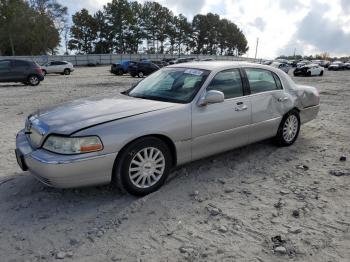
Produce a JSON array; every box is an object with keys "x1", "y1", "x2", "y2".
[{"x1": 15, "y1": 130, "x2": 117, "y2": 188}]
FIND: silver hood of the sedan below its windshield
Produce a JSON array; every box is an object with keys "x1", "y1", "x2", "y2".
[{"x1": 29, "y1": 95, "x2": 176, "y2": 135}]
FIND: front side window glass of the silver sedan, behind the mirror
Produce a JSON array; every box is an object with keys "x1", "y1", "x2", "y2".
[{"x1": 207, "y1": 69, "x2": 243, "y2": 99}]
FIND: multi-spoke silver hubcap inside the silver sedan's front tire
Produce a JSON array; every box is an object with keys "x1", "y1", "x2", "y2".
[{"x1": 129, "y1": 147, "x2": 165, "y2": 188}]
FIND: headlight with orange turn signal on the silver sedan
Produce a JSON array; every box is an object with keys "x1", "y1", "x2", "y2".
[{"x1": 43, "y1": 135, "x2": 103, "y2": 155}]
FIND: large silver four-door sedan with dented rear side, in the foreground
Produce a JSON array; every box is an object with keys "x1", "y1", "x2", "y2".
[{"x1": 16, "y1": 61, "x2": 320, "y2": 195}]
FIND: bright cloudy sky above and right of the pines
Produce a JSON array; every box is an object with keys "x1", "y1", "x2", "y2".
[{"x1": 58, "y1": 0, "x2": 350, "y2": 59}]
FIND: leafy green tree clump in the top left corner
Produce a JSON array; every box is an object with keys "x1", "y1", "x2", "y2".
[{"x1": 0, "y1": 0, "x2": 67, "y2": 55}]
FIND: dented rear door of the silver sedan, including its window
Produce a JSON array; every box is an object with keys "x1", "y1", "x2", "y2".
[{"x1": 245, "y1": 68, "x2": 292, "y2": 142}]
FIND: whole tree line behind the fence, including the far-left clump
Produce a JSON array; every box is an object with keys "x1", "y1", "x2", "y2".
[{"x1": 0, "y1": 0, "x2": 248, "y2": 55}]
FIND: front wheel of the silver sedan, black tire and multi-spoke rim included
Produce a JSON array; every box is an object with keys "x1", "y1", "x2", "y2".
[{"x1": 112, "y1": 137, "x2": 172, "y2": 196}]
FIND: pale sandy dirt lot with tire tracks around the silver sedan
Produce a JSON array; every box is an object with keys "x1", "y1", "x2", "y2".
[{"x1": 0, "y1": 67, "x2": 350, "y2": 262}]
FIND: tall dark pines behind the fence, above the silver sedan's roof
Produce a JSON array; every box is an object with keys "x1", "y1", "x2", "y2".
[{"x1": 67, "y1": 0, "x2": 248, "y2": 55}]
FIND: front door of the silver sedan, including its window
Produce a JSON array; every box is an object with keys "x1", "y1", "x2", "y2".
[{"x1": 192, "y1": 69, "x2": 251, "y2": 160}]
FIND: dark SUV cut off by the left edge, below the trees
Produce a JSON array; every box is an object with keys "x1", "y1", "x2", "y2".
[{"x1": 0, "y1": 59, "x2": 44, "y2": 86}]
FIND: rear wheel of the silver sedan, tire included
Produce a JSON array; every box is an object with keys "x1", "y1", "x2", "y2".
[{"x1": 275, "y1": 110, "x2": 300, "y2": 146}]
